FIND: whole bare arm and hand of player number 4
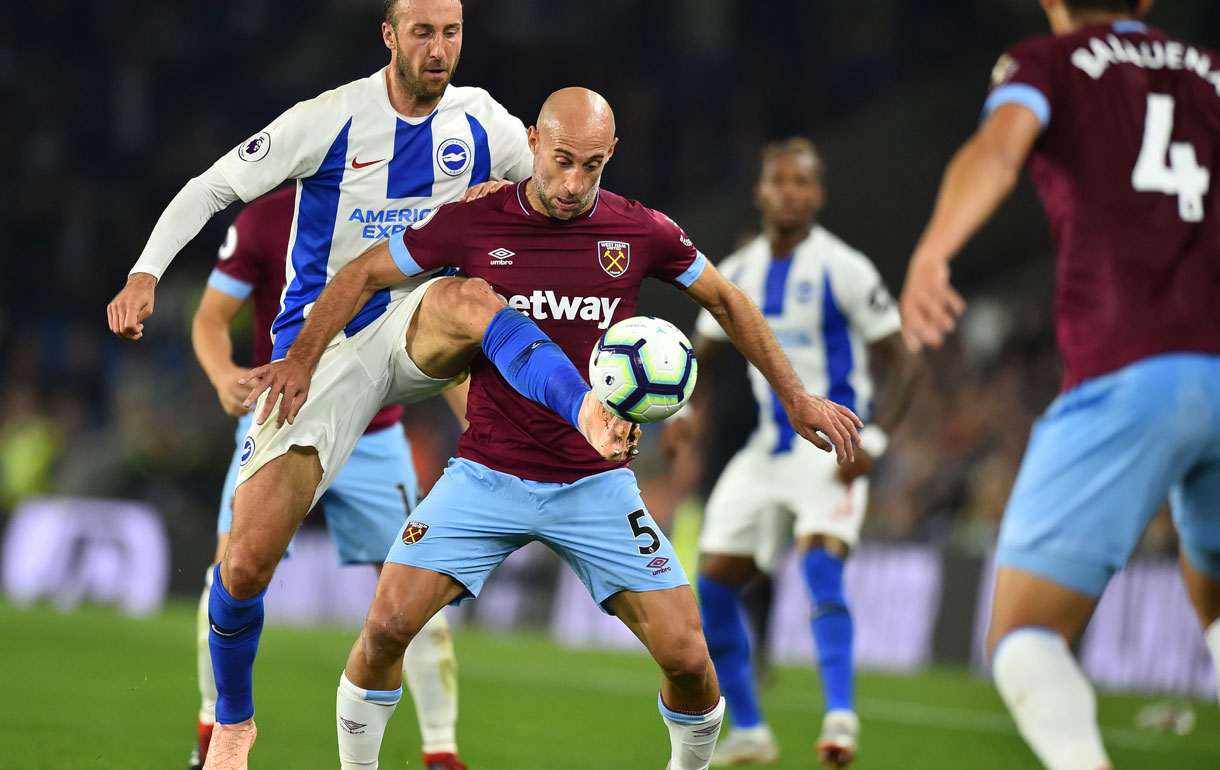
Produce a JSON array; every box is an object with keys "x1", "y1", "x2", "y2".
[{"x1": 898, "y1": 104, "x2": 1042, "y2": 351}]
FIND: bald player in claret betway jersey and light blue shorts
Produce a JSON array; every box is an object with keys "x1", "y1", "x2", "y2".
[{"x1": 255, "y1": 88, "x2": 856, "y2": 770}]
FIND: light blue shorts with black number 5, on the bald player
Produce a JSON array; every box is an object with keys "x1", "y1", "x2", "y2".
[{"x1": 386, "y1": 459, "x2": 691, "y2": 610}]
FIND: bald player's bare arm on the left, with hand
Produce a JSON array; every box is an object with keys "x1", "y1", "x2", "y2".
[{"x1": 242, "y1": 242, "x2": 406, "y2": 427}]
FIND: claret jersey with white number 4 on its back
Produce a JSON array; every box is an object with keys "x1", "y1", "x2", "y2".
[{"x1": 983, "y1": 21, "x2": 1220, "y2": 389}]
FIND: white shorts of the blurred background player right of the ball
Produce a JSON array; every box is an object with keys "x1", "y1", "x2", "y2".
[{"x1": 699, "y1": 439, "x2": 869, "y2": 572}]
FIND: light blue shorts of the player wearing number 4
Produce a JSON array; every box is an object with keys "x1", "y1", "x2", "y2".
[{"x1": 997, "y1": 354, "x2": 1220, "y2": 597}]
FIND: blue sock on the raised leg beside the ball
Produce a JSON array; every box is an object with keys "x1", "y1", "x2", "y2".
[{"x1": 483, "y1": 308, "x2": 589, "y2": 430}]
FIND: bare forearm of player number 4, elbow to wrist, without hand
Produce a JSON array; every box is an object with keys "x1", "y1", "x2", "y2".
[{"x1": 911, "y1": 134, "x2": 1020, "y2": 270}]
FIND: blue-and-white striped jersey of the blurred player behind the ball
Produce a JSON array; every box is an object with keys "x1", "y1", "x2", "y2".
[{"x1": 695, "y1": 226, "x2": 900, "y2": 453}]
